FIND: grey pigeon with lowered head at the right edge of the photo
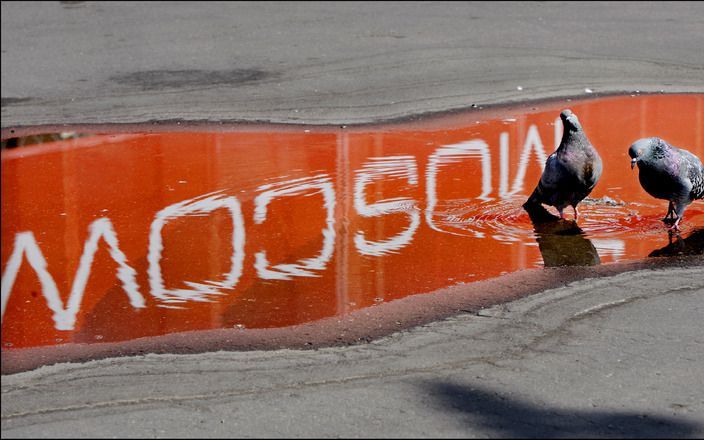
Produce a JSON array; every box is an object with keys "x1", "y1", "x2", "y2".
[{"x1": 628, "y1": 137, "x2": 704, "y2": 230}]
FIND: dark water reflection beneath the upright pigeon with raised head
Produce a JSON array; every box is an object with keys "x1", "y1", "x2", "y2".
[{"x1": 524, "y1": 205, "x2": 601, "y2": 267}]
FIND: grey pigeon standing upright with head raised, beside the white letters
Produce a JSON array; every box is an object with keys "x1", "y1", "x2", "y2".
[{"x1": 523, "y1": 109, "x2": 602, "y2": 221}]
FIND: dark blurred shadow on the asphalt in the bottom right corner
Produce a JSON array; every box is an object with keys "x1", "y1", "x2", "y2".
[{"x1": 423, "y1": 381, "x2": 704, "y2": 438}]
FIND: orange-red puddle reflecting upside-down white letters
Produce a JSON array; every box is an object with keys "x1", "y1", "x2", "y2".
[{"x1": 2, "y1": 95, "x2": 704, "y2": 362}]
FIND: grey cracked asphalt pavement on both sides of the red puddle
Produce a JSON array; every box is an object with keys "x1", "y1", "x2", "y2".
[{"x1": 1, "y1": 2, "x2": 704, "y2": 438}]
